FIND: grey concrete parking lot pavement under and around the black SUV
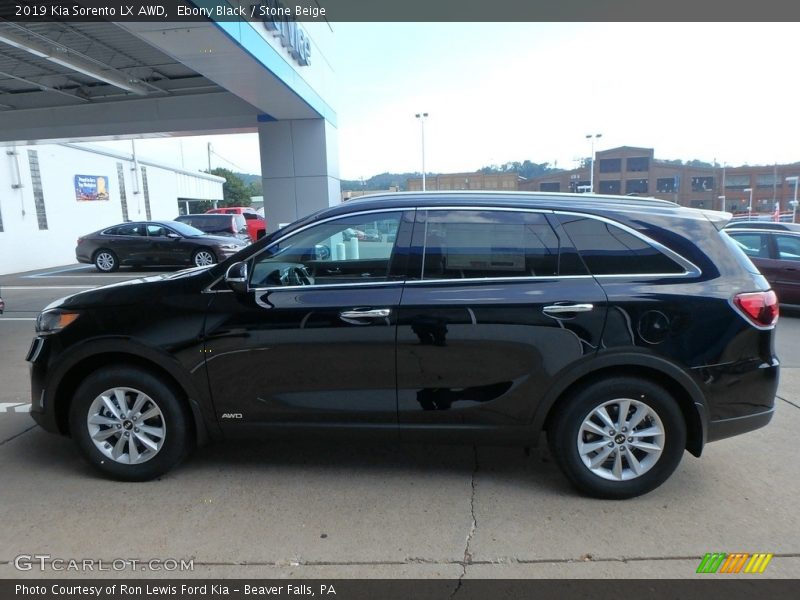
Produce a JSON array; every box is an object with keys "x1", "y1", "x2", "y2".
[{"x1": 0, "y1": 265, "x2": 800, "y2": 579}]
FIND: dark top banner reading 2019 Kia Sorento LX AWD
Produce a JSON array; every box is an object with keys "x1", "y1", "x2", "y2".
[{"x1": 0, "y1": 0, "x2": 800, "y2": 22}]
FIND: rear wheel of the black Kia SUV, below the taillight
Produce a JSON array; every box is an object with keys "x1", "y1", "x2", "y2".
[{"x1": 547, "y1": 377, "x2": 686, "y2": 500}]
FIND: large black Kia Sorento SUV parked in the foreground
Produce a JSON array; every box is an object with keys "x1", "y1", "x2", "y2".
[{"x1": 27, "y1": 192, "x2": 778, "y2": 498}]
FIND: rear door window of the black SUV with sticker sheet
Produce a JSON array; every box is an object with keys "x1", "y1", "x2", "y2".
[{"x1": 412, "y1": 210, "x2": 559, "y2": 279}]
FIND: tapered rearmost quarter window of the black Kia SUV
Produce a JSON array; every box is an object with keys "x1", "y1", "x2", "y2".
[{"x1": 561, "y1": 215, "x2": 686, "y2": 275}]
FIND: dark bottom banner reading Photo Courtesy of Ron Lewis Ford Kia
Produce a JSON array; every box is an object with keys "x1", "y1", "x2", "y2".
[{"x1": 0, "y1": 575, "x2": 800, "y2": 600}]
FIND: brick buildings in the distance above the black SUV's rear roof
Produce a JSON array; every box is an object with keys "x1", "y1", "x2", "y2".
[{"x1": 519, "y1": 146, "x2": 800, "y2": 213}]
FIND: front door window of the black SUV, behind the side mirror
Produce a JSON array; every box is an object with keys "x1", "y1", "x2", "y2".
[{"x1": 250, "y1": 212, "x2": 402, "y2": 287}]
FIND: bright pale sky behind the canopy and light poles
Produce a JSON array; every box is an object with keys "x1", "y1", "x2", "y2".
[{"x1": 86, "y1": 23, "x2": 800, "y2": 179}]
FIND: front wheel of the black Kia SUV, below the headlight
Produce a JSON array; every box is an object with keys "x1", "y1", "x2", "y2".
[{"x1": 69, "y1": 366, "x2": 195, "y2": 481}]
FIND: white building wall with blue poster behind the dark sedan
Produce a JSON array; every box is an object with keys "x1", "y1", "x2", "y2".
[{"x1": 0, "y1": 144, "x2": 224, "y2": 275}]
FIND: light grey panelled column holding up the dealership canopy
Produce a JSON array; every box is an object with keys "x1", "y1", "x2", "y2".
[{"x1": 258, "y1": 119, "x2": 341, "y2": 232}]
